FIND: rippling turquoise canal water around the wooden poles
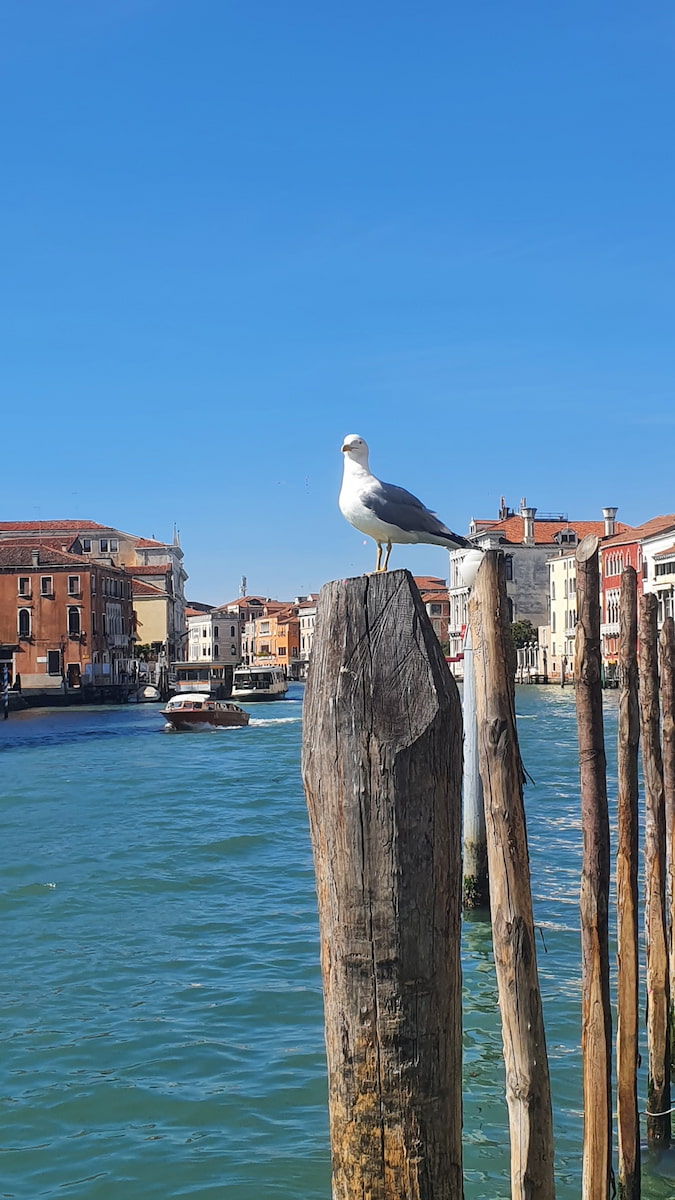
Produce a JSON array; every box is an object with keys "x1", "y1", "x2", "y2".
[{"x1": 0, "y1": 685, "x2": 675, "y2": 1200}]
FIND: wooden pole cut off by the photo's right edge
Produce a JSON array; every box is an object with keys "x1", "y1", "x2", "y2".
[{"x1": 659, "y1": 617, "x2": 675, "y2": 1073}]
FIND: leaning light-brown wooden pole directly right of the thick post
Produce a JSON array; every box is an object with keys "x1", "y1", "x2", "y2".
[{"x1": 468, "y1": 551, "x2": 555, "y2": 1200}]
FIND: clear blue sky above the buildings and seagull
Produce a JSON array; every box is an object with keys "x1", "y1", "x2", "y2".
[{"x1": 0, "y1": 0, "x2": 675, "y2": 602}]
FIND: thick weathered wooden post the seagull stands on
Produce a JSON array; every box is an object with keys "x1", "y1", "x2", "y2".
[{"x1": 303, "y1": 571, "x2": 462, "y2": 1200}]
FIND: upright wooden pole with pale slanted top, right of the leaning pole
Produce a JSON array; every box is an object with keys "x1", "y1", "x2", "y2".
[{"x1": 574, "y1": 534, "x2": 611, "y2": 1200}]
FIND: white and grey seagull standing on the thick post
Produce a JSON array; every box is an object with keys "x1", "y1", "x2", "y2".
[{"x1": 338, "y1": 433, "x2": 473, "y2": 574}]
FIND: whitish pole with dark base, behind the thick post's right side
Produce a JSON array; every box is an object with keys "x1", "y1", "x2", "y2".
[{"x1": 462, "y1": 629, "x2": 490, "y2": 911}]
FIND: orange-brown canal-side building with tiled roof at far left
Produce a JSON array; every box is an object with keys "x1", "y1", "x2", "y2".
[{"x1": 0, "y1": 538, "x2": 135, "y2": 696}]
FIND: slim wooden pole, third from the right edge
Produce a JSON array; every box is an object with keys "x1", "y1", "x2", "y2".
[{"x1": 616, "y1": 566, "x2": 640, "y2": 1200}]
